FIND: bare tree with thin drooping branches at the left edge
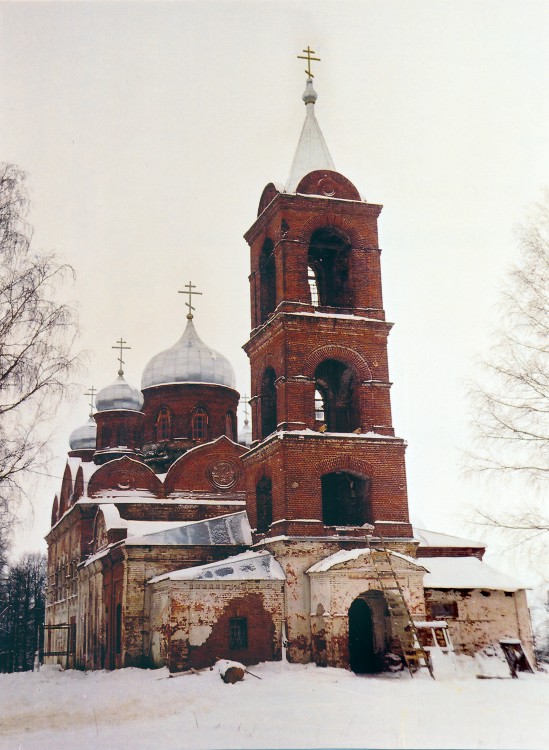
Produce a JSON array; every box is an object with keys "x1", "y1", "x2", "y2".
[{"x1": 0, "y1": 164, "x2": 76, "y2": 523}]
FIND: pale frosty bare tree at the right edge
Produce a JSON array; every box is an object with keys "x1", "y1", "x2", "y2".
[{"x1": 468, "y1": 193, "x2": 549, "y2": 551}]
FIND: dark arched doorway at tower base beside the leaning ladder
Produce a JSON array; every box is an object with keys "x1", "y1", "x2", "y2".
[{"x1": 349, "y1": 591, "x2": 389, "y2": 674}]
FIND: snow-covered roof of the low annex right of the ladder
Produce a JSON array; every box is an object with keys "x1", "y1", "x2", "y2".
[{"x1": 421, "y1": 557, "x2": 526, "y2": 591}]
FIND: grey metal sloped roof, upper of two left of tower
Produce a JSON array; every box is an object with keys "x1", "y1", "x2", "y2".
[{"x1": 126, "y1": 511, "x2": 252, "y2": 546}]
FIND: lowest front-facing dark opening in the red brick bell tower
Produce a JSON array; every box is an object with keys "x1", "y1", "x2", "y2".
[{"x1": 321, "y1": 471, "x2": 372, "y2": 526}]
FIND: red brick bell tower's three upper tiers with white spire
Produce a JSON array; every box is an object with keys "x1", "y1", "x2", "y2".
[{"x1": 243, "y1": 70, "x2": 413, "y2": 548}]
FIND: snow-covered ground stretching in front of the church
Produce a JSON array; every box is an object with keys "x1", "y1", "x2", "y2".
[{"x1": 0, "y1": 660, "x2": 549, "y2": 750}]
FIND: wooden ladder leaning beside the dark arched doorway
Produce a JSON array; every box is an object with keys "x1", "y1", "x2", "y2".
[{"x1": 368, "y1": 540, "x2": 435, "y2": 680}]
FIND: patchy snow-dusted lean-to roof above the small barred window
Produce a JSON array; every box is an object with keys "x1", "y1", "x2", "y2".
[{"x1": 149, "y1": 551, "x2": 286, "y2": 583}]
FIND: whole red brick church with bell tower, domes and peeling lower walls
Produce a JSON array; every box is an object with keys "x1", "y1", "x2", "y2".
[{"x1": 45, "y1": 58, "x2": 533, "y2": 673}]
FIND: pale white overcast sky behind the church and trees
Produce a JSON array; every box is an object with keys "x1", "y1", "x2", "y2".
[{"x1": 0, "y1": 0, "x2": 549, "y2": 576}]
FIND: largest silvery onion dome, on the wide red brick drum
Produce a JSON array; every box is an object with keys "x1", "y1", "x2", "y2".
[{"x1": 141, "y1": 320, "x2": 236, "y2": 389}]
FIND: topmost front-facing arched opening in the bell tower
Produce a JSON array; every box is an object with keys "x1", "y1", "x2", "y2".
[{"x1": 307, "y1": 227, "x2": 352, "y2": 307}]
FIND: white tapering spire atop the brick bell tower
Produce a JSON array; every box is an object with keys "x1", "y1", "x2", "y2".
[{"x1": 286, "y1": 77, "x2": 335, "y2": 193}]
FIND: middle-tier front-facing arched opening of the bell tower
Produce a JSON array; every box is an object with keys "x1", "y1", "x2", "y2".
[{"x1": 315, "y1": 359, "x2": 360, "y2": 432}]
